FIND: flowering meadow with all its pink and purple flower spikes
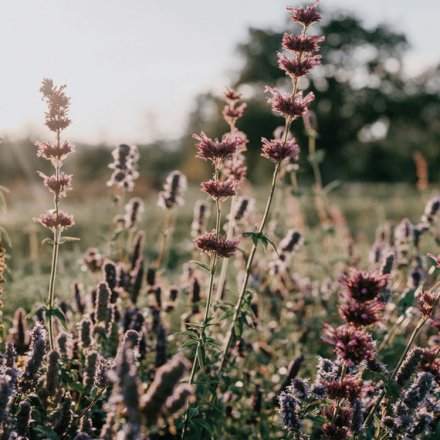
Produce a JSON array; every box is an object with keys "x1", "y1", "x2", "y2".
[{"x1": 0, "y1": 0, "x2": 440, "y2": 440}]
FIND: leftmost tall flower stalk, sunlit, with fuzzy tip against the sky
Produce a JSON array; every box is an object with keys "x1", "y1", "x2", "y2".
[{"x1": 34, "y1": 79, "x2": 74, "y2": 350}]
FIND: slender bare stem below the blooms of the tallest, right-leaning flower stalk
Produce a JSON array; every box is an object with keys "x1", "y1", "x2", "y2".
[{"x1": 219, "y1": 160, "x2": 282, "y2": 373}]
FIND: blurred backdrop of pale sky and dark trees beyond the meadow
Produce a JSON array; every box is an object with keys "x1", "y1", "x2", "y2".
[{"x1": 0, "y1": 0, "x2": 440, "y2": 188}]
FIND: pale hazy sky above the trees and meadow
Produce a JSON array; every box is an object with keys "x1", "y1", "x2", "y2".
[{"x1": 0, "y1": 0, "x2": 440, "y2": 143}]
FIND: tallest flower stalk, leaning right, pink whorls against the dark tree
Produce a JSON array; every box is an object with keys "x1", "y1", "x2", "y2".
[{"x1": 220, "y1": 0, "x2": 324, "y2": 374}]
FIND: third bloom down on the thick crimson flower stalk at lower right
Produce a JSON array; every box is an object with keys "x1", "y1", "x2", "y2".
[{"x1": 322, "y1": 324, "x2": 375, "y2": 367}]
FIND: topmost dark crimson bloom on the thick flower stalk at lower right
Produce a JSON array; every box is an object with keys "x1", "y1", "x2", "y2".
[{"x1": 342, "y1": 269, "x2": 389, "y2": 302}]
